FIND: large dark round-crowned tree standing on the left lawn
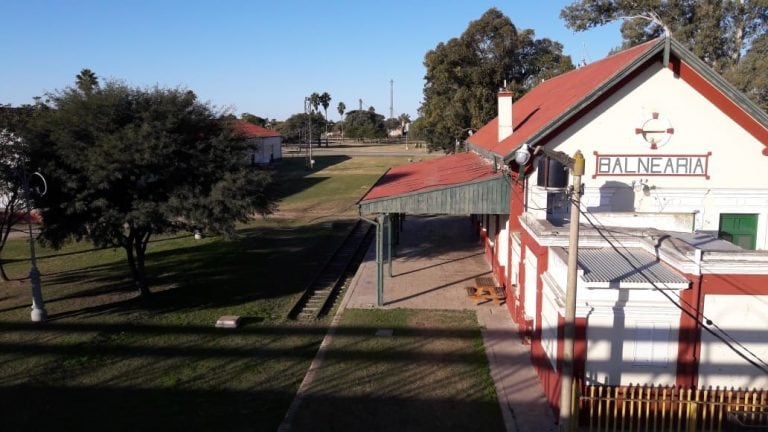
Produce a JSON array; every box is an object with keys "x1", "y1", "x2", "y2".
[{"x1": 28, "y1": 81, "x2": 274, "y2": 296}]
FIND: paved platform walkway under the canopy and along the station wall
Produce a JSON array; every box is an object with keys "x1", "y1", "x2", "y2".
[{"x1": 343, "y1": 216, "x2": 557, "y2": 432}]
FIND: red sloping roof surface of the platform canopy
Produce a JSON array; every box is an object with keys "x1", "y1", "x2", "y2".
[{"x1": 360, "y1": 152, "x2": 502, "y2": 201}]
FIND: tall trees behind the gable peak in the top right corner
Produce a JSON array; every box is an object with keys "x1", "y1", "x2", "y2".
[{"x1": 560, "y1": 0, "x2": 768, "y2": 109}]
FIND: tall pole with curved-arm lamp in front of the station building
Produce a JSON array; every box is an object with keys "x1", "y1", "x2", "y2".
[{"x1": 515, "y1": 144, "x2": 584, "y2": 432}]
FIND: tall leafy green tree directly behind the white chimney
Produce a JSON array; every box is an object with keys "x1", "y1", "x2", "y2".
[{"x1": 419, "y1": 8, "x2": 573, "y2": 151}]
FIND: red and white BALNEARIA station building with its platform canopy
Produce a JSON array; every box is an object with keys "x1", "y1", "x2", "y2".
[{"x1": 359, "y1": 38, "x2": 768, "y2": 412}]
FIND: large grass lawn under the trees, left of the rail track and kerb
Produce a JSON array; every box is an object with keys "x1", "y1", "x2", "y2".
[{"x1": 0, "y1": 157, "x2": 404, "y2": 431}]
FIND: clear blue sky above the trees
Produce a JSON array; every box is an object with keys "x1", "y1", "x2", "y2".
[{"x1": 0, "y1": 0, "x2": 620, "y2": 120}]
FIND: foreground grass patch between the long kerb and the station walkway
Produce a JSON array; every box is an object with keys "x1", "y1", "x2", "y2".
[{"x1": 293, "y1": 309, "x2": 504, "y2": 432}]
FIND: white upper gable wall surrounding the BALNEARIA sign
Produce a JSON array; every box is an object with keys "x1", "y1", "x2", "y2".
[{"x1": 536, "y1": 63, "x2": 768, "y2": 249}]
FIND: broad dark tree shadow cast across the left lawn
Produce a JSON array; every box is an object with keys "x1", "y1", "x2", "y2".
[{"x1": 20, "y1": 223, "x2": 354, "y2": 319}]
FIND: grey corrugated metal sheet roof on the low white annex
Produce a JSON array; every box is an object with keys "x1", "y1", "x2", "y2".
[{"x1": 579, "y1": 248, "x2": 689, "y2": 288}]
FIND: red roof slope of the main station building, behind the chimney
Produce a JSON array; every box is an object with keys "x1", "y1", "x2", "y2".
[{"x1": 468, "y1": 39, "x2": 659, "y2": 157}]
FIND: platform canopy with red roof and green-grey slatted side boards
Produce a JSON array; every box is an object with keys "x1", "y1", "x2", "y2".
[{"x1": 357, "y1": 152, "x2": 511, "y2": 215}]
